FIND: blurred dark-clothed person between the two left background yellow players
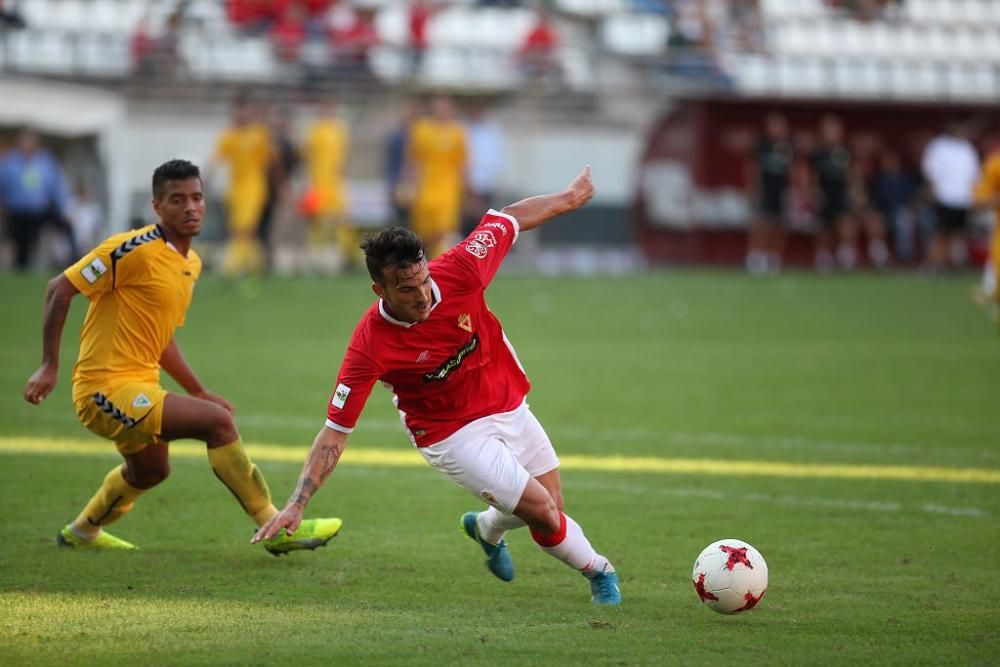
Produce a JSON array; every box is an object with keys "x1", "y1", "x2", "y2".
[{"x1": 257, "y1": 108, "x2": 299, "y2": 269}]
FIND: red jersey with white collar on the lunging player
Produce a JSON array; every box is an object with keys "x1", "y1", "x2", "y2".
[{"x1": 326, "y1": 210, "x2": 531, "y2": 447}]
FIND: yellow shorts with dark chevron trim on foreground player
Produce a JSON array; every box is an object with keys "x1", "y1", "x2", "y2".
[{"x1": 75, "y1": 382, "x2": 167, "y2": 454}]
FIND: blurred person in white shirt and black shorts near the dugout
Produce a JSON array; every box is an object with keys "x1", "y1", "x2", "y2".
[{"x1": 921, "y1": 122, "x2": 979, "y2": 271}]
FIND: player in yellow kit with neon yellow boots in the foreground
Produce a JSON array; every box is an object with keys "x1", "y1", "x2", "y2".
[{"x1": 24, "y1": 160, "x2": 341, "y2": 555}]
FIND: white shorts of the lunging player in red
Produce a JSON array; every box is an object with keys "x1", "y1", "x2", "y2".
[{"x1": 419, "y1": 403, "x2": 559, "y2": 514}]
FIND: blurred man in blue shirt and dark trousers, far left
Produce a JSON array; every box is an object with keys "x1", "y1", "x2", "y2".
[{"x1": 0, "y1": 129, "x2": 76, "y2": 271}]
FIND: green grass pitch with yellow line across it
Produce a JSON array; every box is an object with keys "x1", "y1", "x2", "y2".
[{"x1": 0, "y1": 272, "x2": 1000, "y2": 665}]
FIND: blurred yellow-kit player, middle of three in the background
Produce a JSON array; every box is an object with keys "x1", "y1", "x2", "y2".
[{"x1": 302, "y1": 101, "x2": 360, "y2": 264}]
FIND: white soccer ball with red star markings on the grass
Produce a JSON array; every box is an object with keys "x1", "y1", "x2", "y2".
[{"x1": 691, "y1": 540, "x2": 767, "y2": 614}]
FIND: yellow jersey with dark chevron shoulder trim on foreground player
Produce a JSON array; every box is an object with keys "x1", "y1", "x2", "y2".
[{"x1": 64, "y1": 225, "x2": 201, "y2": 401}]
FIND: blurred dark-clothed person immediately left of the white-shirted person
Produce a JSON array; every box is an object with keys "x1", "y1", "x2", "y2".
[{"x1": 872, "y1": 150, "x2": 920, "y2": 262}]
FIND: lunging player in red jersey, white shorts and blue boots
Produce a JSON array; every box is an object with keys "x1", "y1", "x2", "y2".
[{"x1": 253, "y1": 166, "x2": 621, "y2": 604}]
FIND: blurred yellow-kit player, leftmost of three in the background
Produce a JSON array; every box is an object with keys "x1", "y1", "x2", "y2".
[{"x1": 212, "y1": 100, "x2": 274, "y2": 276}]
